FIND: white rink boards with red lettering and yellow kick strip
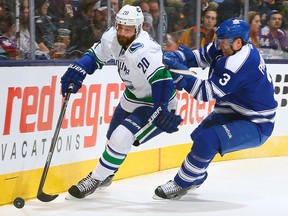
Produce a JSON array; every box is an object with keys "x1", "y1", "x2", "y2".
[{"x1": 0, "y1": 64, "x2": 288, "y2": 205}]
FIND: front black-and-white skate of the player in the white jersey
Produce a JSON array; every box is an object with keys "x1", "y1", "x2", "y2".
[{"x1": 68, "y1": 172, "x2": 101, "y2": 199}]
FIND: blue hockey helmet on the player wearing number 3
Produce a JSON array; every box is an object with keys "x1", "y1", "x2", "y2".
[{"x1": 216, "y1": 18, "x2": 250, "y2": 44}]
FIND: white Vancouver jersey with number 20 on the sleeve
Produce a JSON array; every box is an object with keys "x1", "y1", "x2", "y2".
[{"x1": 88, "y1": 27, "x2": 176, "y2": 112}]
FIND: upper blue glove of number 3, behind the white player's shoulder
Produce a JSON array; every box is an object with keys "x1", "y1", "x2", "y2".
[{"x1": 163, "y1": 50, "x2": 188, "y2": 70}]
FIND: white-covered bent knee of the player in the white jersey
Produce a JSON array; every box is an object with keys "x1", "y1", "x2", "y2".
[{"x1": 108, "y1": 125, "x2": 135, "y2": 154}]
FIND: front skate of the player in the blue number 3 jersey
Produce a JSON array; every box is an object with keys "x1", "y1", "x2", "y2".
[{"x1": 153, "y1": 180, "x2": 189, "y2": 199}]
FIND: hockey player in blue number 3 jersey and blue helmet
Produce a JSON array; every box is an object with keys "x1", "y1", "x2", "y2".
[{"x1": 155, "y1": 18, "x2": 277, "y2": 199}]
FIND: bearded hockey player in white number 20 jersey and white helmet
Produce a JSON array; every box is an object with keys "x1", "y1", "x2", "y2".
[{"x1": 61, "y1": 5, "x2": 182, "y2": 198}]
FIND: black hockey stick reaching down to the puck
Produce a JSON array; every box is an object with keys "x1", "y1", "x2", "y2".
[{"x1": 37, "y1": 83, "x2": 74, "y2": 202}]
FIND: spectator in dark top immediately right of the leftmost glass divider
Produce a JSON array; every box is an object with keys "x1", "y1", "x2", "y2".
[{"x1": 35, "y1": 0, "x2": 65, "y2": 56}]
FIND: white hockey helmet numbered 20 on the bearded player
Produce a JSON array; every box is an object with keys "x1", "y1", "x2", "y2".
[{"x1": 115, "y1": 5, "x2": 144, "y2": 36}]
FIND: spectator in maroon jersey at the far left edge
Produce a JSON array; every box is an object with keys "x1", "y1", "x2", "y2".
[{"x1": 0, "y1": 13, "x2": 17, "y2": 60}]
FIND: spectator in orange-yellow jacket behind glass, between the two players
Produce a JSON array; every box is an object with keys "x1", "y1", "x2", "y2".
[{"x1": 178, "y1": 8, "x2": 217, "y2": 49}]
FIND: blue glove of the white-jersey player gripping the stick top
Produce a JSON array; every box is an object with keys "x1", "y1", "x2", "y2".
[{"x1": 61, "y1": 63, "x2": 86, "y2": 97}]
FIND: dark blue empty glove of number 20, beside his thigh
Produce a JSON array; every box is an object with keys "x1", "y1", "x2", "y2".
[{"x1": 149, "y1": 104, "x2": 183, "y2": 133}]
